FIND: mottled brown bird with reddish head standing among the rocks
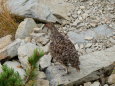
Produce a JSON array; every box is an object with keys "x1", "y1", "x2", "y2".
[{"x1": 47, "y1": 23, "x2": 80, "y2": 73}]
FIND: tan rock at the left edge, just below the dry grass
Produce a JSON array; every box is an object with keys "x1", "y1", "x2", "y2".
[{"x1": 0, "y1": 35, "x2": 12, "y2": 49}]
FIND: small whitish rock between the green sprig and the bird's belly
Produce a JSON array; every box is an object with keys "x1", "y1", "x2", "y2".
[{"x1": 39, "y1": 54, "x2": 52, "y2": 69}]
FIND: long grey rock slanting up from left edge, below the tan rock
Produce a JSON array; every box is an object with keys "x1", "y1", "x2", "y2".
[{"x1": 0, "y1": 39, "x2": 22, "y2": 60}]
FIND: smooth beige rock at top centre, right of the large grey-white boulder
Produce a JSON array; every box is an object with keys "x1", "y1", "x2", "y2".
[{"x1": 39, "y1": 0, "x2": 74, "y2": 20}]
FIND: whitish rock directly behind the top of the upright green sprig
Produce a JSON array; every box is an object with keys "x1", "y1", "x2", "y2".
[{"x1": 18, "y1": 43, "x2": 38, "y2": 69}]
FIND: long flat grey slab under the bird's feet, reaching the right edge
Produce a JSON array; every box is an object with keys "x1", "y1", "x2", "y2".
[{"x1": 46, "y1": 46, "x2": 115, "y2": 86}]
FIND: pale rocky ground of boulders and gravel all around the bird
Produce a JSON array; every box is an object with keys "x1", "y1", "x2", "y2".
[{"x1": 0, "y1": 0, "x2": 115, "y2": 86}]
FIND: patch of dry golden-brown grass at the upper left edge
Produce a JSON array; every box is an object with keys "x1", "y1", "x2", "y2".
[{"x1": 0, "y1": 0, "x2": 18, "y2": 37}]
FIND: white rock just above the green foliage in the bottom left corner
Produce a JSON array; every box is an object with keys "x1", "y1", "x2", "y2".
[{"x1": 4, "y1": 61, "x2": 26, "y2": 79}]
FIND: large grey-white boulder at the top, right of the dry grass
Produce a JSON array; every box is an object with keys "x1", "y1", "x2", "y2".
[{"x1": 7, "y1": 0, "x2": 58, "y2": 22}]
